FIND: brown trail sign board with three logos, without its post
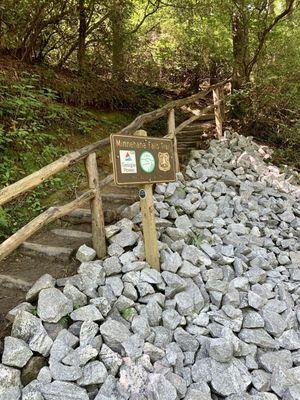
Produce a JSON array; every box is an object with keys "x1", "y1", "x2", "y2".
[{"x1": 110, "y1": 135, "x2": 176, "y2": 185}]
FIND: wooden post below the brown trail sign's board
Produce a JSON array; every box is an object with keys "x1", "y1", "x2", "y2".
[{"x1": 140, "y1": 184, "x2": 160, "y2": 271}]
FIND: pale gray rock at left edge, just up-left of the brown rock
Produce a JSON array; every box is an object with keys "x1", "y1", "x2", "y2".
[{"x1": 2, "y1": 336, "x2": 33, "y2": 368}]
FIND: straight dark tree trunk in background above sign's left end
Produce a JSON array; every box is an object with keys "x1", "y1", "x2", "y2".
[{"x1": 111, "y1": 0, "x2": 126, "y2": 81}]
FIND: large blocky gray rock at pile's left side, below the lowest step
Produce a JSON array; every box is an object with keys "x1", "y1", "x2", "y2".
[{"x1": 37, "y1": 288, "x2": 73, "y2": 323}]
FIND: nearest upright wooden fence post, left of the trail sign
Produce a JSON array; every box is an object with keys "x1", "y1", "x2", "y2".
[{"x1": 85, "y1": 153, "x2": 106, "y2": 258}]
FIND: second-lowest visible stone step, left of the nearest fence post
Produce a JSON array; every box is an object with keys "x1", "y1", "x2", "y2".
[{"x1": 20, "y1": 242, "x2": 77, "y2": 262}]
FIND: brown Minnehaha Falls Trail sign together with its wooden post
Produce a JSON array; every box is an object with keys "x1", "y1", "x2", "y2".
[{"x1": 111, "y1": 130, "x2": 176, "y2": 271}]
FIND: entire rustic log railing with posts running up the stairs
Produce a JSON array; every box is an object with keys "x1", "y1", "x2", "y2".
[{"x1": 0, "y1": 82, "x2": 226, "y2": 261}]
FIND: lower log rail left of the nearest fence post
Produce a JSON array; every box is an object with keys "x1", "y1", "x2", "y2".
[{"x1": 0, "y1": 190, "x2": 95, "y2": 261}]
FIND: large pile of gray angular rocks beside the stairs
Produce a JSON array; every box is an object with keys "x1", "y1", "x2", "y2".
[{"x1": 0, "y1": 132, "x2": 300, "y2": 400}]
